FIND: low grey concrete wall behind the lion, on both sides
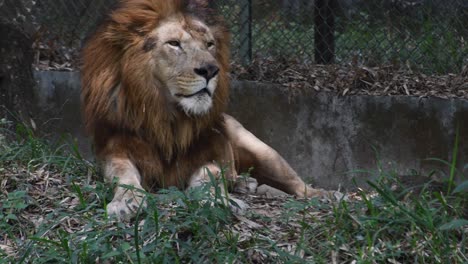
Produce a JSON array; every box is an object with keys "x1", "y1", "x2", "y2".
[{"x1": 31, "y1": 72, "x2": 468, "y2": 188}]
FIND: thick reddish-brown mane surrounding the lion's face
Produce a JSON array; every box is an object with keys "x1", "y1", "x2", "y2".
[{"x1": 81, "y1": 0, "x2": 229, "y2": 159}]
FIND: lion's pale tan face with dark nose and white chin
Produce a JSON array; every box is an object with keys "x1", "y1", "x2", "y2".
[{"x1": 144, "y1": 16, "x2": 219, "y2": 115}]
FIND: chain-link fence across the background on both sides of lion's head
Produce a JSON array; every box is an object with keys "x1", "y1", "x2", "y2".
[{"x1": 0, "y1": 0, "x2": 468, "y2": 73}]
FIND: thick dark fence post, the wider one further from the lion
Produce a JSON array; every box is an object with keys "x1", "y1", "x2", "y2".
[{"x1": 314, "y1": 0, "x2": 336, "y2": 64}]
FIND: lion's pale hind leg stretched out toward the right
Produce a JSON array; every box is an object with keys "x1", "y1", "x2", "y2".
[{"x1": 224, "y1": 115, "x2": 328, "y2": 197}]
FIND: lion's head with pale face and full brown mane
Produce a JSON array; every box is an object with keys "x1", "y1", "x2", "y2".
[{"x1": 82, "y1": 0, "x2": 229, "y2": 145}]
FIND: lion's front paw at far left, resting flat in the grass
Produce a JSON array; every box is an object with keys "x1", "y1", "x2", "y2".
[{"x1": 107, "y1": 190, "x2": 146, "y2": 221}]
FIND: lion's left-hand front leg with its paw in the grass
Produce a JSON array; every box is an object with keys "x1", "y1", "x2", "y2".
[{"x1": 103, "y1": 157, "x2": 143, "y2": 220}]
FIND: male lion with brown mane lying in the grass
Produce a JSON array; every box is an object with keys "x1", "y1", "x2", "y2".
[{"x1": 82, "y1": 0, "x2": 330, "y2": 219}]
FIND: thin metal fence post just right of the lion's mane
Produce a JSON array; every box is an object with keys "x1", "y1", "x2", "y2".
[{"x1": 239, "y1": 0, "x2": 252, "y2": 65}]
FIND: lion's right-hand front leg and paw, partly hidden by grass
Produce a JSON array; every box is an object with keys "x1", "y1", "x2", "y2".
[{"x1": 188, "y1": 163, "x2": 247, "y2": 214}]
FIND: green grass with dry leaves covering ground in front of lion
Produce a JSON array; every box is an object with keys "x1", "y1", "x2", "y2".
[{"x1": 0, "y1": 121, "x2": 468, "y2": 263}]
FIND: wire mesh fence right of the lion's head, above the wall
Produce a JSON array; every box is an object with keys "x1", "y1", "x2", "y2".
[{"x1": 218, "y1": 0, "x2": 468, "y2": 73}]
